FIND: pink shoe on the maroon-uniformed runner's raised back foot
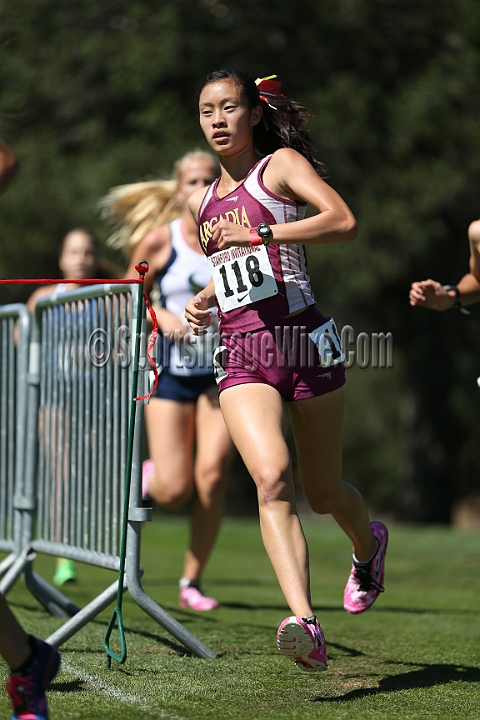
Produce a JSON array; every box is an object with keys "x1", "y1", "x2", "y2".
[{"x1": 343, "y1": 522, "x2": 388, "y2": 615}]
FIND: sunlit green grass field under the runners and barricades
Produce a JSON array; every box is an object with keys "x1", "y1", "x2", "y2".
[{"x1": 0, "y1": 517, "x2": 480, "y2": 720}]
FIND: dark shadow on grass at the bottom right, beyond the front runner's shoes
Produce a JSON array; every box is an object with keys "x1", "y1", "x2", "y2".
[{"x1": 314, "y1": 662, "x2": 480, "y2": 703}]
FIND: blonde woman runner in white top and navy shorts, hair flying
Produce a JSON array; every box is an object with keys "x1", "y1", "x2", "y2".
[{"x1": 102, "y1": 152, "x2": 232, "y2": 611}]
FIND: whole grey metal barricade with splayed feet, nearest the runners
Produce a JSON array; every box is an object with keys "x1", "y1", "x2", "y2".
[{"x1": 0, "y1": 283, "x2": 215, "y2": 657}]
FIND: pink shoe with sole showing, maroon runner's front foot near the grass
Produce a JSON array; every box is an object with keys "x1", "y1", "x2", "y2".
[{"x1": 277, "y1": 616, "x2": 327, "y2": 672}]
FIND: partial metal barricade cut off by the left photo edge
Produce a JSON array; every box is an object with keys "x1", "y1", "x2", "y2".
[{"x1": 0, "y1": 304, "x2": 30, "y2": 577}]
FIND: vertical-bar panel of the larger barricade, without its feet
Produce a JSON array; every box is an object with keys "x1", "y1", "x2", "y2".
[{"x1": 33, "y1": 286, "x2": 132, "y2": 569}]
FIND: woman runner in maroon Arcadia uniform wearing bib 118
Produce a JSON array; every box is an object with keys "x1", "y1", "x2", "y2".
[{"x1": 185, "y1": 70, "x2": 388, "y2": 670}]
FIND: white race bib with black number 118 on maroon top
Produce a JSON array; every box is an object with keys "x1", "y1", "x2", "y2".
[{"x1": 208, "y1": 245, "x2": 278, "y2": 312}]
